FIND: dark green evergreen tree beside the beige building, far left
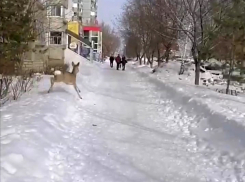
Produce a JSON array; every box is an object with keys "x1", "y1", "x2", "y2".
[{"x1": 0, "y1": 0, "x2": 35, "y2": 73}]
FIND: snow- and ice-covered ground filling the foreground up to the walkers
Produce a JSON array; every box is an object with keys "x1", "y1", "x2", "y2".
[{"x1": 0, "y1": 54, "x2": 245, "y2": 182}]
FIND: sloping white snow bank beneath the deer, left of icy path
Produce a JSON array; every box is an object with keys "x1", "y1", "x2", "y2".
[{"x1": 0, "y1": 76, "x2": 86, "y2": 182}]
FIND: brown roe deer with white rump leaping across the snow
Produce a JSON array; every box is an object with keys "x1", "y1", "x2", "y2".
[{"x1": 48, "y1": 62, "x2": 82, "y2": 99}]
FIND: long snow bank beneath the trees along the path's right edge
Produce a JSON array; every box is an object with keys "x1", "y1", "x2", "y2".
[{"x1": 130, "y1": 61, "x2": 245, "y2": 127}]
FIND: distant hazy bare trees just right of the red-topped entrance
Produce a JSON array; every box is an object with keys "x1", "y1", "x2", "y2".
[{"x1": 100, "y1": 22, "x2": 120, "y2": 57}]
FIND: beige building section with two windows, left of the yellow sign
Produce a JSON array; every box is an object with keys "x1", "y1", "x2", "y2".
[{"x1": 23, "y1": 0, "x2": 68, "y2": 71}]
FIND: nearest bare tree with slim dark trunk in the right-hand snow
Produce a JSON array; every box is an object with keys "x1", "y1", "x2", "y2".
[{"x1": 161, "y1": 0, "x2": 232, "y2": 85}]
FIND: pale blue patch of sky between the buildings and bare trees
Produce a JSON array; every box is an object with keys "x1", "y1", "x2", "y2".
[{"x1": 98, "y1": 0, "x2": 126, "y2": 25}]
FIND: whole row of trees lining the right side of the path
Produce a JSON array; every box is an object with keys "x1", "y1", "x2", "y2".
[{"x1": 120, "y1": 0, "x2": 245, "y2": 85}]
